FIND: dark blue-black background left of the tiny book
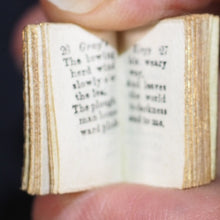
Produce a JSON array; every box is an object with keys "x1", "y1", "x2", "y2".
[{"x1": 0, "y1": 0, "x2": 37, "y2": 220}]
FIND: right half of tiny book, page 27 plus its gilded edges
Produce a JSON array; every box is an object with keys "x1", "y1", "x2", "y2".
[{"x1": 119, "y1": 15, "x2": 218, "y2": 188}]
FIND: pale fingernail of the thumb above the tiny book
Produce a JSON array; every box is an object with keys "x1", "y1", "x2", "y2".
[{"x1": 48, "y1": 0, "x2": 104, "y2": 14}]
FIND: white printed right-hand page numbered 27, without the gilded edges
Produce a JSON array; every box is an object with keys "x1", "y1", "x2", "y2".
[{"x1": 120, "y1": 19, "x2": 185, "y2": 187}]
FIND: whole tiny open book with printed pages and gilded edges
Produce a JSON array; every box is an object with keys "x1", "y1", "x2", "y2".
[{"x1": 22, "y1": 14, "x2": 219, "y2": 194}]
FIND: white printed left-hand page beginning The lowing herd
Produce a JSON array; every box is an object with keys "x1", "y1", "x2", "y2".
[{"x1": 45, "y1": 24, "x2": 121, "y2": 193}]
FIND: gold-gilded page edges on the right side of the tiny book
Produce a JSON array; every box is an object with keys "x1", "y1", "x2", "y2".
[{"x1": 182, "y1": 14, "x2": 213, "y2": 188}]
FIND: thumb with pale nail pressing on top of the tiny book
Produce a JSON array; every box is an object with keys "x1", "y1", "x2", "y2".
[{"x1": 41, "y1": 0, "x2": 217, "y2": 30}]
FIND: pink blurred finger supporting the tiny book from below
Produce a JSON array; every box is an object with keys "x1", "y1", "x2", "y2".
[{"x1": 33, "y1": 181, "x2": 220, "y2": 220}]
